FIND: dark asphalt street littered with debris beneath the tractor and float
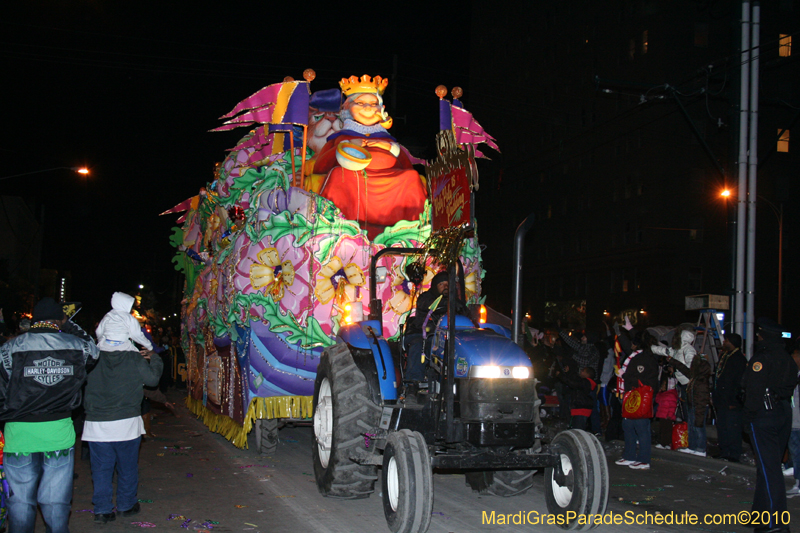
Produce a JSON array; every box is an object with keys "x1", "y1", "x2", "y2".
[{"x1": 31, "y1": 392, "x2": 800, "y2": 533}]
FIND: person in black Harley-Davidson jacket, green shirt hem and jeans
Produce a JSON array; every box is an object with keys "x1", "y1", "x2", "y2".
[{"x1": 0, "y1": 298, "x2": 99, "y2": 533}]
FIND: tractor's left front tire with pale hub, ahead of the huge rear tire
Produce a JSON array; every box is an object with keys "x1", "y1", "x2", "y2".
[{"x1": 381, "y1": 429, "x2": 433, "y2": 533}]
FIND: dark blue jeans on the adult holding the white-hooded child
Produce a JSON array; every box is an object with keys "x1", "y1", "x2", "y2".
[{"x1": 89, "y1": 437, "x2": 142, "y2": 515}]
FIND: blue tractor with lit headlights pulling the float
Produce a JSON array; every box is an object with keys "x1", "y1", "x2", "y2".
[{"x1": 312, "y1": 218, "x2": 608, "y2": 533}]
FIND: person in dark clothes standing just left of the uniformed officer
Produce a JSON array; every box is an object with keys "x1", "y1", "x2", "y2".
[{"x1": 712, "y1": 333, "x2": 747, "y2": 463}]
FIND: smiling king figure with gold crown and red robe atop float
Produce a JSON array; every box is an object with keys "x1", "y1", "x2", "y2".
[{"x1": 312, "y1": 75, "x2": 427, "y2": 239}]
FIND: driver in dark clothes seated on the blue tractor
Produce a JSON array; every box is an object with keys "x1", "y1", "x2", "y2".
[{"x1": 404, "y1": 272, "x2": 469, "y2": 383}]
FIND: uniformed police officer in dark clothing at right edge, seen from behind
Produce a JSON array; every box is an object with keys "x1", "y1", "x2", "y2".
[{"x1": 742, "y1": 318, "x2": 797, "y2": 532}]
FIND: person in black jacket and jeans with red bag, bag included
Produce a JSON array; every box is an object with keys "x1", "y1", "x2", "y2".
[{"x1": 616, "y1": 331, "x2": 658, "y2": 470}]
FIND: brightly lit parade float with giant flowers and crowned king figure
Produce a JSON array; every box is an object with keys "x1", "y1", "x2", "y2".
[{"x1": 169, "y1": 69, "x2": 497, "y2": 452}]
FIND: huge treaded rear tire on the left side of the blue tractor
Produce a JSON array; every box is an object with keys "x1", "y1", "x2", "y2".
[{"x1": 312, "y1": 343, "x2": 381, "y2": 499}]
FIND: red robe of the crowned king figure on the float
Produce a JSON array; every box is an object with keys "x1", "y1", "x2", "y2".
[{"x1": 314, "y1": 130, "x2": 428, "y2": 240}]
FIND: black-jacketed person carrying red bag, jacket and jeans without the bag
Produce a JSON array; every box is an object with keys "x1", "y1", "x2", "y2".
[{"x1": 616, "y1": 331, "x2": 658, "y2": 470}]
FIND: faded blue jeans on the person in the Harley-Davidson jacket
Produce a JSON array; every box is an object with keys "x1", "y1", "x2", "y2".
[{"x1": 3, "y1": 448, "x2": 75, "y2": 533}]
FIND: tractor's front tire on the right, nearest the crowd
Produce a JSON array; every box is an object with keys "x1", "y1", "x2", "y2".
[{"x1": 544, "y1": 429, "x2": 608, "y2": 531}]
